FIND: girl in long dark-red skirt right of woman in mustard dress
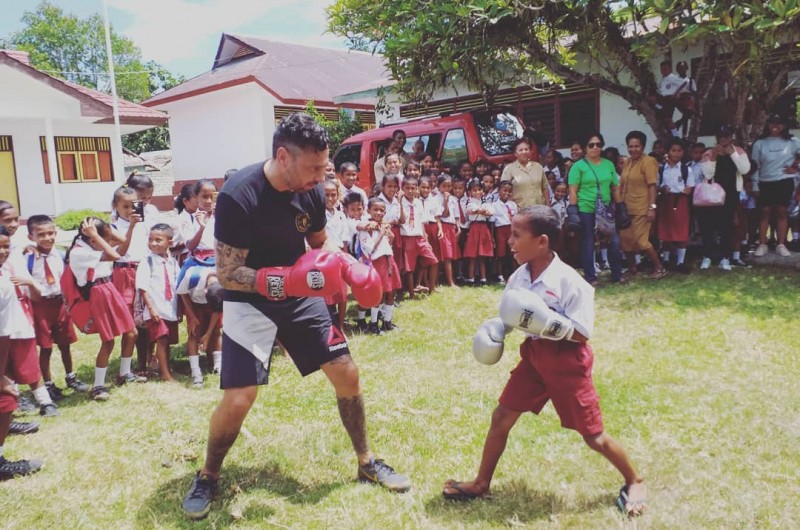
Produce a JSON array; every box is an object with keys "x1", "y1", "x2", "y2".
[{"x1": 656, "y1": 139, "x2": 694, "y2": 274}]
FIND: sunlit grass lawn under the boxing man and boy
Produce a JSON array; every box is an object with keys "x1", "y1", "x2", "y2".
[{"x1": 0, "y1": 269, "x2": 800, "y2": 529}]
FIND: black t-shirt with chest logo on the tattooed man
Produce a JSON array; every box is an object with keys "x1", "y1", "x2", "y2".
[{"x1": 214, "y1": 162, "x2": 326, "y2": 301}]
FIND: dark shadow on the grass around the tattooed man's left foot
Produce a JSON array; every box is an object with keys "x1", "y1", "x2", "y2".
[{"x1": 136, "y1": 462, "x2": 347, "y2": 528}]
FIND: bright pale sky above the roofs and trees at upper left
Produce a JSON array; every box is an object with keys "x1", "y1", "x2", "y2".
[{"x1": 0, "y1": 0, "x2": 345, "y2": 78}]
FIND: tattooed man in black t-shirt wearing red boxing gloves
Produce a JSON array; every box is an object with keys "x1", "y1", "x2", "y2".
[{"x1": 183, "y1": 113, "x2": 411, "y2": 519}]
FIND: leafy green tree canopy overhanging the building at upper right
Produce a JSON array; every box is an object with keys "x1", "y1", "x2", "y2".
[{"x1": 327, "y1": 0, "x2": 800, "y2": 142}]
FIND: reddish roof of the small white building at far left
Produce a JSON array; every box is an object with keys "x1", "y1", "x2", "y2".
[{"x1": 0, "y1": 50, "x2": 167, "y2": 125}]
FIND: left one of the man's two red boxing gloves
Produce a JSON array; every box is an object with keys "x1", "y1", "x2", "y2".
[{"x1": 256, "y1": 249, "x2": 342, "y2": 302}]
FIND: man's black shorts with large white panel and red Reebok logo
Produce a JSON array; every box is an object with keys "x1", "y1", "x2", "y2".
[{"x1": 220, "y1": 298, "x2": 350, "y2": 389}]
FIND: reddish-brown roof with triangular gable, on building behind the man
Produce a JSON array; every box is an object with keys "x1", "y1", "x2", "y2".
[{"x1": 143, "y1": 34, "x2": 386, "y2": 110}]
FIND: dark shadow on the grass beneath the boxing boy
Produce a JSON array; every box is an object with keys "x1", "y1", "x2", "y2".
[{"x1": 425, "y1": 481, "x2": 615, "y2": 525}]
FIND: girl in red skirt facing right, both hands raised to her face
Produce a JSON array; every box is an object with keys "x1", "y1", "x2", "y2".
[{"x1": 68, "y1": 217, "x2": 139, "y2": 401}]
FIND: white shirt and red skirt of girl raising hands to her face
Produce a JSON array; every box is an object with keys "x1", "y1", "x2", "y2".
[{"x1": 69, "y1": 240, "x2": 136, "y2": 341}]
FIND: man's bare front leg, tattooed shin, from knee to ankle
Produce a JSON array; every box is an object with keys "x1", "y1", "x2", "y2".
[{"x1": 322, "y1": 355, "x2": 372, "y2": 464}]
